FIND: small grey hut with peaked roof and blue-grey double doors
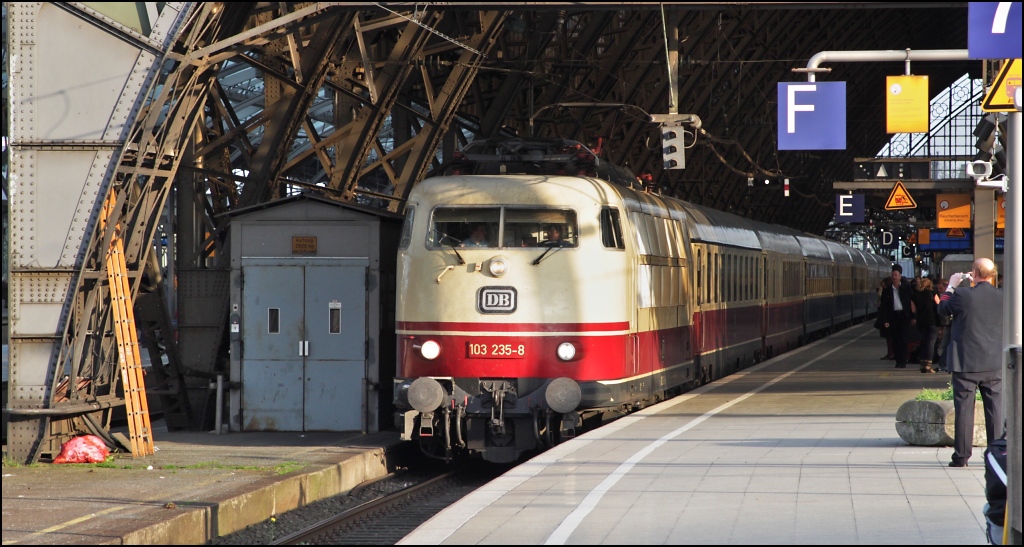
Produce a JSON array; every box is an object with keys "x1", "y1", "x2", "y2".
[{"x1": 228, "y1": 194, "x2": 401, "y2": 432}]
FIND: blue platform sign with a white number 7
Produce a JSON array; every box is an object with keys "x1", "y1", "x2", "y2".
[{"x1": 967, "y1": 2, "x2": 1021, "y2": 58}]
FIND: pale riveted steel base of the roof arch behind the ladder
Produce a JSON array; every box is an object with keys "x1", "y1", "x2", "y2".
[{"x1": 8, "y1": 2, "x2": 193, "y2": 461}]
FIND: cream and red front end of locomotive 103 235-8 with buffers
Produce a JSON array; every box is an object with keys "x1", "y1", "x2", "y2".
[{"x1": 394, "y1": 169, "x2": 629, "y2": 462}]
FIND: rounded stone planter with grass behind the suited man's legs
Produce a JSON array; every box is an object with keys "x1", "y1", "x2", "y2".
[{"x1": 896, "y1": 399, "x2": 988, "y2": 447}]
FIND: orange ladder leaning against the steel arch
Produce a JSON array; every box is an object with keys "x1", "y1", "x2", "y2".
[{"x1": 99, "y1": 190, "x2": 155, "y2": 458}]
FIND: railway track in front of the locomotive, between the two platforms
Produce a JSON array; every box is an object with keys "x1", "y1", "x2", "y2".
[{"x1": 270, "y1": 466, "x2": 506, "y2": 545}]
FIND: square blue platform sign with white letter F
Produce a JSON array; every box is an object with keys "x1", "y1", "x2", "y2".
[{"x1": 778, "y1": 82, "x2": 846, "y2": 150}]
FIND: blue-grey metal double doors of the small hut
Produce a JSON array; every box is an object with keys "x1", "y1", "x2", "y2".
[{"x1": 242, "y1": 264, "x2": 367, "y2": 431}]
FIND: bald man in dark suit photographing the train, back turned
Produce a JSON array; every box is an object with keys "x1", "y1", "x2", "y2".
[{"x1": 939, "y1": 258, "x2": 1005, "y2": 467}]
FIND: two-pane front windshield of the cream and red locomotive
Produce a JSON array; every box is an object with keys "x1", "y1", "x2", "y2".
[{"x1": 427, "y1": 207, "x2": 579, "y2": 249}]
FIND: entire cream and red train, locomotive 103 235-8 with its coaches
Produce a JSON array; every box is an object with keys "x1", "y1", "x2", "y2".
[{"x1": 394, "y1": 138, "x2": 881, "y2": 462}]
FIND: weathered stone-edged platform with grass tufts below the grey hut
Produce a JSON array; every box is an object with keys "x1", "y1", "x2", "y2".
[{"x1": 3, "y1": 430, "x2": 407, "y2": 545}]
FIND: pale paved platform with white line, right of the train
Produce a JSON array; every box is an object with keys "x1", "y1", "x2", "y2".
[{"x1": 400, "y1": 324, "x2": 986, "y2": 545}]
